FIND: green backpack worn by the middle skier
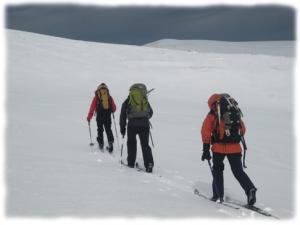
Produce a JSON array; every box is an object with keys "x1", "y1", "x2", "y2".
[{"x1": 127, "y1": 83, "x2": 150, "y2": 119}]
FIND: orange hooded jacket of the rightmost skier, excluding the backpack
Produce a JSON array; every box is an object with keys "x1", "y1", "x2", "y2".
[{"x1": 201, "y1": 94, "x2": 246, "y2": 154}]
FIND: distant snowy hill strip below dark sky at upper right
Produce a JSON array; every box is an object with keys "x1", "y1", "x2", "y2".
[{"x1": 145, "y1": 39, "x2": 295, "y2": 57}]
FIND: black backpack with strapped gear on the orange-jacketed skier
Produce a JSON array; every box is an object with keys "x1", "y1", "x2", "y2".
[{"x1": 212, "y1": 94, "x2": 243, "y2": 143}]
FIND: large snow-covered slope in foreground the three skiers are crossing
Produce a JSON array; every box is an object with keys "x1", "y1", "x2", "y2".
[{"x1": 5, "y1": 30, "x2": 295, "y2": 218}]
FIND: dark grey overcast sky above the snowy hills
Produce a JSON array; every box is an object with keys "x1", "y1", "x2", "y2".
[{"x1": 6, "y1": 4, "x2": 295, "y2": 45}]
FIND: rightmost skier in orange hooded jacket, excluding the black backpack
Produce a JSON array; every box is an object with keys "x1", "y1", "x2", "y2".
[{"x1": 201, "y1": 94, "x2": 257, "y2": 205}]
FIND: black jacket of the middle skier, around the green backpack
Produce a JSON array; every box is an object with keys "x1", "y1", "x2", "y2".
[{"x1": 120, "y1": 98, "x2": 153, "y2": 128}]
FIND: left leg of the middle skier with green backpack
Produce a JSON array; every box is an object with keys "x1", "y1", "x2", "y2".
[{"x1": 127, "y1": 127, "x2": 137, "y2": 167}]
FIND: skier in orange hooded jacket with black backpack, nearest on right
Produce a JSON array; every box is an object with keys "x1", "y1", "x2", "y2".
[{"x1": 201, "y1": 94, "x2": 257, "y2": 206}]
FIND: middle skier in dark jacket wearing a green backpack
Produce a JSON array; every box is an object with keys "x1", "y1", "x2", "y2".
[{"x1": 120, "y1": 84, "x2": 154, "y2": 173}]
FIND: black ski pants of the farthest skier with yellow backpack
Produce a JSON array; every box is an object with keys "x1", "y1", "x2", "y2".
[{"x1": 96, "y1": 114, "x2": 114, "y2": 144}]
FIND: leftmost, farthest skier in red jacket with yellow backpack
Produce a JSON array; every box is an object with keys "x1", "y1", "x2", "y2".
[{"x1": 87, "y1": 83, "x2": 116, "y2": 152}]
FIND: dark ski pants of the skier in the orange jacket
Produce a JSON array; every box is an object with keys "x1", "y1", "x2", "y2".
[{"x1": 212, "y1": 153, "x2": 255, "y2": 198}]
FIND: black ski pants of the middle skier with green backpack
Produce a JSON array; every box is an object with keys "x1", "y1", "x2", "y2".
[{"x1": 127, "y1": 126, "x2": 154, "y2": 168}]
